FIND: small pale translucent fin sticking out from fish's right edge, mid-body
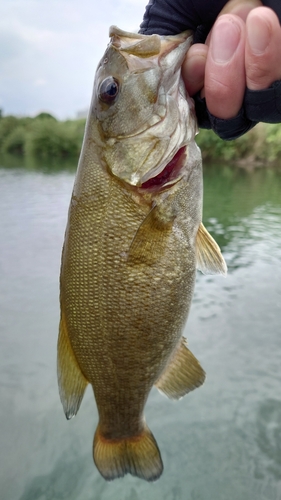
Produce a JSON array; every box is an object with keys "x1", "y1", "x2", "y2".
[{"x1": 196, "y1": 222, "x2": 227, "y2": 274}]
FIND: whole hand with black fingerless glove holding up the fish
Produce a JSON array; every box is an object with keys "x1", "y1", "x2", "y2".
[{"x1": 140, "y1": 0, "x2": 281, "y2": 140}]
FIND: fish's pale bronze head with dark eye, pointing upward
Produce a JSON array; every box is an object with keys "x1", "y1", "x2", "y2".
[{"x1": 90, "y1": 26, "x2": 197, "y2": 187}]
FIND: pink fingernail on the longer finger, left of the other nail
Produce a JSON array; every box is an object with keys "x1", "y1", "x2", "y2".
[{"x1": 210, "y1": 20, "x2": 241, "y2": 64}]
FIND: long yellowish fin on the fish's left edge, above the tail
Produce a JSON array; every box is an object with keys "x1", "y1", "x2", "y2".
[{"x1": 57, "y1": 314, "x2": 88, "y2": 420}]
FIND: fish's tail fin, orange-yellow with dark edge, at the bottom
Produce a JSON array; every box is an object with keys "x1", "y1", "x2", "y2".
[{"x1": 93, "y1": 425, "x2": 163, "y2": 481}]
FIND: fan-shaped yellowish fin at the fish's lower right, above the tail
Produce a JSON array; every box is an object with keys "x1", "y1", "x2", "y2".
[{"x1": 155, "y1": 337, "x2": 206, "y2": 399}]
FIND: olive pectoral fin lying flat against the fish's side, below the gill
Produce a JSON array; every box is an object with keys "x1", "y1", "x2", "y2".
[{"x1": 128, "y1": 206, "x2": 175, "y2": 264}]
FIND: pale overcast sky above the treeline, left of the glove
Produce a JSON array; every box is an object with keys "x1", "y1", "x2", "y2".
[{"x1": 0, "y1": 0, "x2": 148, "y2": 119}]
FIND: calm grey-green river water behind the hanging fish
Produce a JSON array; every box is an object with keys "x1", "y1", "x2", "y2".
[{"x1": 0, "y1": 157, "x2": 281, "y2": 500}]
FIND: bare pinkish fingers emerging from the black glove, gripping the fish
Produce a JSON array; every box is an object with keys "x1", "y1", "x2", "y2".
[{"x1": 182, "y1": 0, "x2": 281, "y2": 121}]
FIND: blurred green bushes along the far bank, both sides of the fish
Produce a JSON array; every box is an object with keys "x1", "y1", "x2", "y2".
[{"x1": 0, "y1": 113, "x2": 281, "y2": 168}]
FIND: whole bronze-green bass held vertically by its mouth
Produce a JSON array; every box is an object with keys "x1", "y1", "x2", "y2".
[{"x1": 57, "y1": 26, "x2": 226, "y2": 481}]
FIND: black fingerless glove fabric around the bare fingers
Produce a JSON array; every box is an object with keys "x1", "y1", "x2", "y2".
[{"x1": 140, "y1": 0, "x2": 281, "y2": 140}]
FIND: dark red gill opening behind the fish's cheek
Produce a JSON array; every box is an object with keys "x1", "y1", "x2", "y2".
[{"x1": 139, "y1": 146, "x2": 186, "y2": 191}]
